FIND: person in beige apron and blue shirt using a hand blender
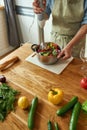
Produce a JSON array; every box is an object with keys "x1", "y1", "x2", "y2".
[{"x1": 33, "y1": 0, "x2": 87, "y2": 59}]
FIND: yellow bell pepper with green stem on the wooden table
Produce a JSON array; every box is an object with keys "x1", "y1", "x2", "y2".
[{"x1": 48, "y1": 88, "x2": 63, "y2": 105}]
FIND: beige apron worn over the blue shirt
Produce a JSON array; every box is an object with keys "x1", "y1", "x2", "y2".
[{"x1": 51, "y1": 0, "x2": 84, "y2": 57}]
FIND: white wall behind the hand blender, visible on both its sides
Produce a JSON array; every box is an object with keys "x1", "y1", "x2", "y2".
[{"x1": 15, "y1": 0, "x2": 51, "y2": 44}]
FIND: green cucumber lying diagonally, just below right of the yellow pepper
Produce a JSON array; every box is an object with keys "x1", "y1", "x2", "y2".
[{"x1": 56, "y1": 96, "x2": 78, "y2": 116}]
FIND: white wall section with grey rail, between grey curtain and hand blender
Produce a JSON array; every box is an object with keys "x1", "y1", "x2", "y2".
[{"x1": 15, "y1": 0, "x2": 38, "y2": 43}]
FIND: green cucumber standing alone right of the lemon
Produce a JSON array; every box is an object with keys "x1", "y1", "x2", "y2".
[{"x1": 28, "y1": 97, "x2": 38, "y2": 130}]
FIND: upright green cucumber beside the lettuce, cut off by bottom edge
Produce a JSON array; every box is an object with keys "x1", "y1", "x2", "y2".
[{"x1": 69, "y1": 102, "x2": 81, "y2": 130}]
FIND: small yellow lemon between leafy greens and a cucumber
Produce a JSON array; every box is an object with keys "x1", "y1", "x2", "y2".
[{"x1": 18, "y1": 96, "x2": 29, "y2": 109}]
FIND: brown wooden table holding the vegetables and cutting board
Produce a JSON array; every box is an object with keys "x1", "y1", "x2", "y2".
[{"x1": 0, "y1": 43, "x2": 87, "y2": 130}]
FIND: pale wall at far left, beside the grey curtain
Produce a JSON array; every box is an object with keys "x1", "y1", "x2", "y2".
[{"x1": 0, "y1": 0, "x2": 13, "y2": 57}]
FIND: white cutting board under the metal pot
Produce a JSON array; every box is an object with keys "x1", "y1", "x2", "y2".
[{"x1": 25, "y1": 53, "x2": 73, "y2": 74}]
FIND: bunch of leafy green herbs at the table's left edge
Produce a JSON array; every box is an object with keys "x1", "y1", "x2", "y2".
[{"x1": 0, "y1": 83, "x2": 18, "y2": 121}]
